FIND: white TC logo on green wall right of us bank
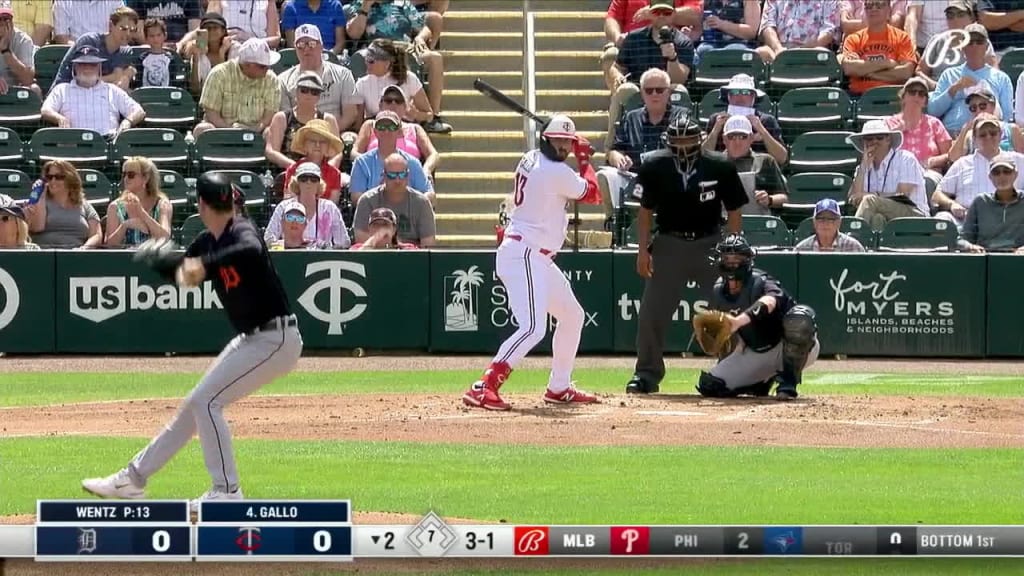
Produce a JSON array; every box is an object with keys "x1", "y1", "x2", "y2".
[{"x1": 299, "y1": 260, "x2": 367, "y2": 336}]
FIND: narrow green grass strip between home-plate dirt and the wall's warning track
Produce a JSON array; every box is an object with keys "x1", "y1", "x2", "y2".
[{"x1": 0, "y1": 369, "x2": 1024, "y2": 406}]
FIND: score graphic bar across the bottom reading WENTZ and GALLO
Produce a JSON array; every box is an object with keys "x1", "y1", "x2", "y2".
[{"x1": 0, "y1": 500, "x2": 1024, "y2": 562}]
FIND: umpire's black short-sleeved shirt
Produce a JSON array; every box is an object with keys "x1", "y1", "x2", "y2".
[{"x1": 634, "y1": 149, "x2": 748, "y2": 237}]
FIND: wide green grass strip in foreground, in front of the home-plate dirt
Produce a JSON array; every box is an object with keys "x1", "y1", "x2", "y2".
[{"x1": 0, "y1": 438, "x2": 1024, "y2": 525}]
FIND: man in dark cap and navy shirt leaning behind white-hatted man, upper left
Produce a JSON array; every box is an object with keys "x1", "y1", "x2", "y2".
[{"x1": 50, "y1": 5, "x2": 139, "y2": 91}]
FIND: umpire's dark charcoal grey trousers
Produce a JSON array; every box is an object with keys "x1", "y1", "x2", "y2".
[{"x1": 633, "y1": 234, "x2": 720, "y2": 384}]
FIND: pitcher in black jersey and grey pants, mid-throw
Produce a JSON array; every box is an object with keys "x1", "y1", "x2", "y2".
[{"x1": 82, "y1": 172, "x2": 302, "y2": 505}]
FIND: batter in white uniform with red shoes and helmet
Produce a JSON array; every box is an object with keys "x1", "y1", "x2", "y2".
[{"x1": 462, "y1": 114, "x2": 601, "y2": 410}]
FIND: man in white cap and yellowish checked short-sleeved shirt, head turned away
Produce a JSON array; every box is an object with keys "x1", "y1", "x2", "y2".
[{"x1": 193, "y1": 38, "x2": 281, "y2": 137}]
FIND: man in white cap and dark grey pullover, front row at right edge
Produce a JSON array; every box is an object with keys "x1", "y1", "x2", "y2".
[{"x1": 958, "y1": 153, "x2": 1024, "y2": 254}]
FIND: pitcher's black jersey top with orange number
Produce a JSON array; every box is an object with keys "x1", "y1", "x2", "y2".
[{"x1": 185, "y1": 215, "x2": 292, "y2": 333}]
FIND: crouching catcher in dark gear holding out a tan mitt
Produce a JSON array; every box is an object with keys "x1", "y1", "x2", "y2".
[{"x1": 693, "y1": 234, "x2": 820, "y2": 401}]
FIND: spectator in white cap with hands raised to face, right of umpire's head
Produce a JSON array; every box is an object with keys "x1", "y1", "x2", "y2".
[{"x1": 705, "y1": 74, "x2": 790, "y2": 165}]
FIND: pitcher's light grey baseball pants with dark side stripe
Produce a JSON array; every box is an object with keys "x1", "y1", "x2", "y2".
[{"x1": 128, "y1": 319, "x2": 302, "y2": 492}]
